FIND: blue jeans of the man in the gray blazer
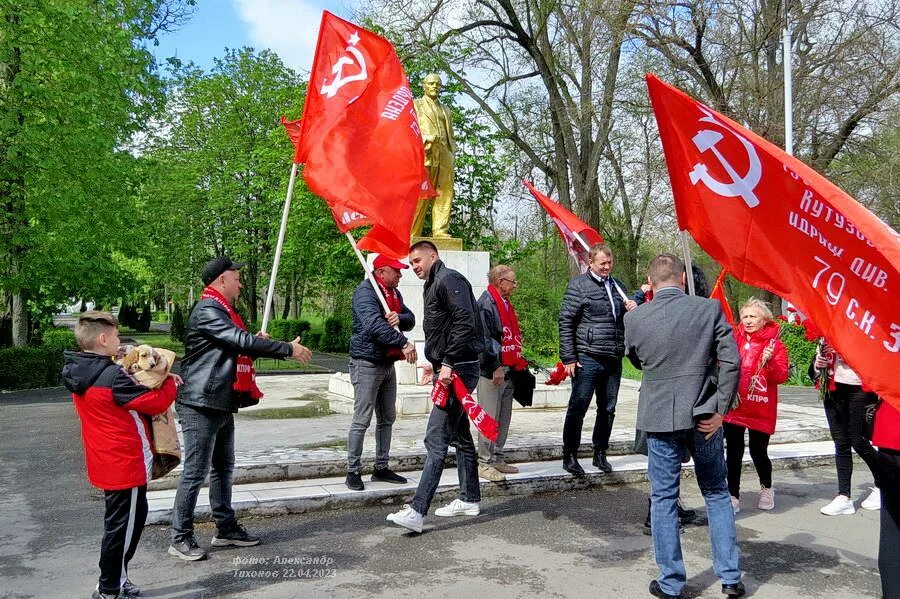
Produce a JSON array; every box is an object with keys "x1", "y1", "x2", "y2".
[{"x1": 647, "y1": 428, "x2": 741, "y2": 595}]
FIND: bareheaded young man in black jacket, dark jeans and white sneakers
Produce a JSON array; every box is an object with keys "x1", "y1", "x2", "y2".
[{"x1": 387, "y1": 241, "x2": 484, "y2": 532}]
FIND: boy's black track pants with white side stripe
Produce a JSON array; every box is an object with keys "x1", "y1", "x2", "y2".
[{"x1": 99, "y1": 485, "x2": 147, "y2": 595}]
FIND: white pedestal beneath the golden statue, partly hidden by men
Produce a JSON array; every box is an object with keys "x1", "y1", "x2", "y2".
[{"x1": 328, "y1": 248, "x2": 488, "y2": 415}]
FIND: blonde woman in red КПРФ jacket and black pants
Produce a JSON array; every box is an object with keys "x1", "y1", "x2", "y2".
[{"x1": 724, "y1": 298, "x2": 788, "y2": 514}]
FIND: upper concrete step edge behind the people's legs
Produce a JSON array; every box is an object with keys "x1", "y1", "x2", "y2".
[{"x1": 148, "y1": 427, "x2": 831, "y2": 491}]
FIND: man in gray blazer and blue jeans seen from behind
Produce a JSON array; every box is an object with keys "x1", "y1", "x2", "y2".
[{"x1": 625, "y1": 254, "x2": 745, "y2": 598}]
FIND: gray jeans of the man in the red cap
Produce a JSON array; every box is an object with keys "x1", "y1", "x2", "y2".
[{"x1": 347, "y1": 359, "x2": 397, "y2": 474}]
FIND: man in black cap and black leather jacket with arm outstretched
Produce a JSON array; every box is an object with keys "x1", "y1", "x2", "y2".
[{"x1": 169, "y1": 256, "x2": 312, "y2": 561}]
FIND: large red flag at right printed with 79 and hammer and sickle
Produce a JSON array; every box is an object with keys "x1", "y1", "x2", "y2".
[{"x1": 647, "y1": 74, "x2": 900, "y2": 408}]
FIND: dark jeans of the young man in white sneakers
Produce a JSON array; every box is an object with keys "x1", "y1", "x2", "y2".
[{"x1": 411, "y1": 362, "x2": 481, "y2": 516}]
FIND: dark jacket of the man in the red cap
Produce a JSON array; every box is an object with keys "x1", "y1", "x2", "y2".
[{"x1": 350, "y1": 279, "x2": 416, "y2": 364}]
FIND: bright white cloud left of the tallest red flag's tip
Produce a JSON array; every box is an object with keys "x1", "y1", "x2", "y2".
[{"x1": 233, "y1": 0, "x2": 344, "y2": 73}]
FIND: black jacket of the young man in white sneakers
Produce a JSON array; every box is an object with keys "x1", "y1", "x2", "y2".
[{"x1": 422, "y1": 260, "x2": 484, "y2": 367}]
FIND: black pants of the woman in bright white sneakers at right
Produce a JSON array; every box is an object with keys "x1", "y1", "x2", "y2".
[{"x1": 825, "y1": 383, "x2": 881, "y2": 497}]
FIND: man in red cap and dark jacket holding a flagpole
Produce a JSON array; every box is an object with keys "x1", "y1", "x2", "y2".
[{"x1": 346, "y1": 255, "x2": 416, "y2": 491}]
